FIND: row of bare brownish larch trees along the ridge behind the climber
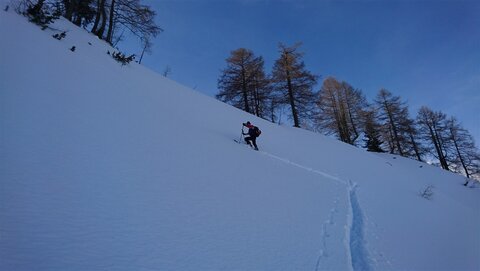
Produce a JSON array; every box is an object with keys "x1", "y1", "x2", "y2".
[{"x1": 216, "y1": 43, "x2": 480, "y2": 182}]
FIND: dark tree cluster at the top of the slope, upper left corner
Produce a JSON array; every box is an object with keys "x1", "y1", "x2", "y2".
[{"x1": 17, "y1": 0, "x2": 163, "y2": 50}]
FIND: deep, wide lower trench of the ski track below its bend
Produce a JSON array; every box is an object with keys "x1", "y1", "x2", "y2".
[{"x1": 345, "y1": 181, "x2": 373, "y2": 271}]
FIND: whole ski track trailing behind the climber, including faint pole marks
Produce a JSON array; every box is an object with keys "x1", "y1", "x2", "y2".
[{"x1": 255, "y1": 151, "x2": 375, "y2": 271}]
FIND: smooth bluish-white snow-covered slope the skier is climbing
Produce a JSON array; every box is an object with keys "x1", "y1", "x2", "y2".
[{"x1": 0, "y1": 10, "x2": 480, "y2": 270}]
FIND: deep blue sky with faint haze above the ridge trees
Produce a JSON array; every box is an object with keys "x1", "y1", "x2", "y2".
[{"x1": 121, "y1": 0, "x2": 480, "y2": 143}]
